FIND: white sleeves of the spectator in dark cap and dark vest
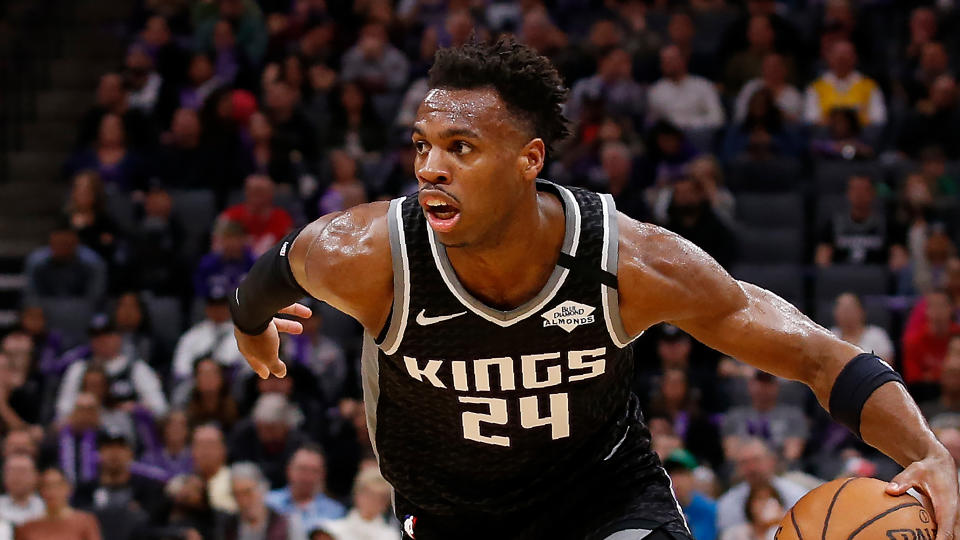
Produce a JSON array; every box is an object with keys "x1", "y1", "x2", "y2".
[{"x1": 57, "y1": 355, "x2": 167, "y2": 419}]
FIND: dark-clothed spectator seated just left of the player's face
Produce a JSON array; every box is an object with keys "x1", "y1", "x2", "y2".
[{"x1": 323, "y1": 82, "x2": 387, "y2": 159}]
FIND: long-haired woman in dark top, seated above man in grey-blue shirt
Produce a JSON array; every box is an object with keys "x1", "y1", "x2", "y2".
[{"x1": 64, "y1": 170, "x2": 119, "y2": 261}]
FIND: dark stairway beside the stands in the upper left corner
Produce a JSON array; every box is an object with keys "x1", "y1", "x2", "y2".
[{"x1": 0, "y1": 0, "x2": 133, "y2": 329}]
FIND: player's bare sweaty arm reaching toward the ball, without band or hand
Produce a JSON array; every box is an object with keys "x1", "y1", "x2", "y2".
[{"x1": 618, "y1": 216, "x2": 945, "y2": 465}]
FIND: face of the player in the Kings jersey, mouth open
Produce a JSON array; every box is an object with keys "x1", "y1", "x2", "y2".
[{"x1": 413, "y1": 88, "x2": 543, "y2": 247}]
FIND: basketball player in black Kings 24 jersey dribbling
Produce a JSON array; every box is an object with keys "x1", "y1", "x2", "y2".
[{"x1": 231, "y1": 40, "x2": 957, "y2": 540}]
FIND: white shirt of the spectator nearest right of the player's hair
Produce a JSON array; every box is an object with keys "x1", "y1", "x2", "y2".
[{"x1": 647, "y1": 75, "x2": 723, "y2": 129}]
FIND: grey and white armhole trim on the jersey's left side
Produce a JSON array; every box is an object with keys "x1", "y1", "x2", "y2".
[{"x1": 377, "y1": 197, "x2": 410, "y2": 354}]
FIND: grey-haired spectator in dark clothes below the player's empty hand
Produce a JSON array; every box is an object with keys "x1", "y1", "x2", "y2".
[{"x1": 229, "y1": 393, "x2": 307, "y2": 490}]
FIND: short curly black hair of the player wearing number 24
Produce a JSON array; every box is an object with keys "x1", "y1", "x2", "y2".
[{"x1": 429, "y1": 36, "x2": 570, "y2": 151}]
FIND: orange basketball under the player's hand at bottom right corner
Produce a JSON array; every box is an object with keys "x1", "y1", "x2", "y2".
[{"x1": 774, "y1": 478, "x2": 937, "y2": 540}]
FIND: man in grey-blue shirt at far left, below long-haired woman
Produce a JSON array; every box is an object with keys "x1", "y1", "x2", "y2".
[{"x1": 23, "y1": 222, "x2": 107, "y2": 306}]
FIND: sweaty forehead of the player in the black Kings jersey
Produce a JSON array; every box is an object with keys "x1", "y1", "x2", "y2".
[{"x1": 414, "y1": 87, "x2": 521, "y2": 135}]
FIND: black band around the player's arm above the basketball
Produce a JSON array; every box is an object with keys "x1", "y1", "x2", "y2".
[{"x1": 830, "y1": 353, "x2": 903, "y2": 440}]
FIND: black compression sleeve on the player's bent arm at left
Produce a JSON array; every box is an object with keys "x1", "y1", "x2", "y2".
[{"x1": 230, "y1": 227, "x2": 310, "y2": 335}]
